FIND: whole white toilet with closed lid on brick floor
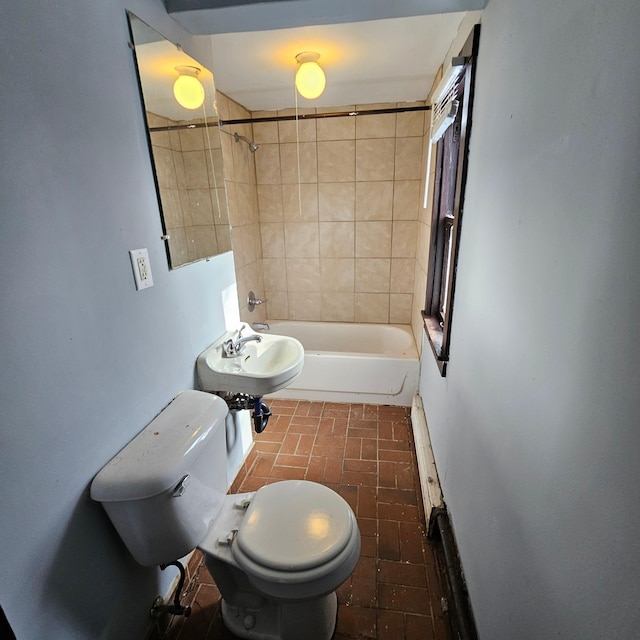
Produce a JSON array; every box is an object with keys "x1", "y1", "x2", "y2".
[{"x1": 91, "y1": 391, "x2": 360, "y2": 640}]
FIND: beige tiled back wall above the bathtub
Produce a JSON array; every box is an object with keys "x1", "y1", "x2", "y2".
[{"x1": 252, "y1": 103, "x2": 427, "y2": 324}]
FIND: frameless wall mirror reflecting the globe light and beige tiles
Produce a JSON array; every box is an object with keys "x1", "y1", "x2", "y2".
[{"x1": 128, "y1": 13, "x2": 231, "y2": 269}]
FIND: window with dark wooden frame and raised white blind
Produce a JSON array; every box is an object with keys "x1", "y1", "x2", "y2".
[{"x1": 422, "y1": 25, "x2": 480, "y2": 376}]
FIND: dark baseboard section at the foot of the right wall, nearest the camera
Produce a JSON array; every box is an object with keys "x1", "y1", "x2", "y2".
[{"x1": 429, "y1": 507, "x2": 478, "y2": 640}]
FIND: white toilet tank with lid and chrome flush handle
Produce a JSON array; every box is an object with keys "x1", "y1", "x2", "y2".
[{"x1": 91, "y1": 391, "x2": 228, "y2": 566}]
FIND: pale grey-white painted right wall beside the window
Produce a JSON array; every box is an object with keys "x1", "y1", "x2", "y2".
[{"x1": 420, "y1": 0, "x2": 640, "y2": 640}]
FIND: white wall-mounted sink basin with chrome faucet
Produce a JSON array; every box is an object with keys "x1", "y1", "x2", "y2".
[{"x1": 196, "y1": 325, "x2": 304, "y2": 396}]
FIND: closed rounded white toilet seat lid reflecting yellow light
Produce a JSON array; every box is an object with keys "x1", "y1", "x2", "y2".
[{"x1": 236, "y1": 480, "x2": 355, "y2": 571}]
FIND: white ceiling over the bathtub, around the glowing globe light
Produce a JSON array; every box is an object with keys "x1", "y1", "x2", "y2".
[{"x1": 210, "y1": 12, "x2": 465, "y2": 111}]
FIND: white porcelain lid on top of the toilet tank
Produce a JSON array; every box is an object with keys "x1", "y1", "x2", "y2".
[{"x1": 91, "y1": 391, "x2": 228, "y2": 502}]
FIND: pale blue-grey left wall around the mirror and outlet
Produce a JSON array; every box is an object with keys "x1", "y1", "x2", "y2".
[{"x1": 0, "y1": 0, "x2": 235, "y2": 640}]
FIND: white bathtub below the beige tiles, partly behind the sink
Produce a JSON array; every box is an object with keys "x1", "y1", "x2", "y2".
[{"x1": 262, "y1": 320, "x2": 420, "y2": 407}]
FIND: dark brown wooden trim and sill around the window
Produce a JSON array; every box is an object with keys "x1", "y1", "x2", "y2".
[{"x1": 422, "y1": 25, "x2": 480, "y2": 376}]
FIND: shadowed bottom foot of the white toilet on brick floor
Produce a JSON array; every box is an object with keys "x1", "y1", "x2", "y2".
[{"x1": 222, "y1": 591, "x2": 338, "y2": 640}]
